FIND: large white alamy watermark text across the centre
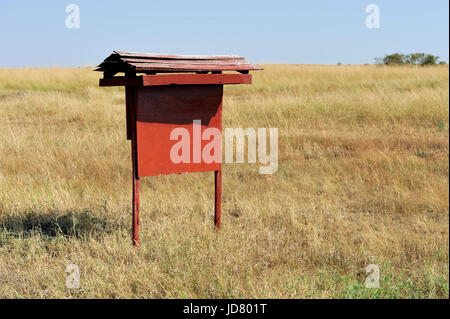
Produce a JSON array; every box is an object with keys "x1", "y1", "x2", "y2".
[{"x1": 170, "y1": 120, "x2": 278, "y2": 174}]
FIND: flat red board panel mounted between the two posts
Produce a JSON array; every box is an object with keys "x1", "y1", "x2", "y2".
[{"x1": 136, "y1": 85, "x2": 223, "y2": 177}]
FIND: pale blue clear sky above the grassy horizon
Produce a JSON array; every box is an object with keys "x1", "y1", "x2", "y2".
[{"x1": 0, "y1": 0, "x2": 449, "y2": 67}]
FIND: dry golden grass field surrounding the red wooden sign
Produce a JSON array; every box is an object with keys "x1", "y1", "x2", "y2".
[{"x1": 0, "y1": 65, "x2": 449, "y2": 298}]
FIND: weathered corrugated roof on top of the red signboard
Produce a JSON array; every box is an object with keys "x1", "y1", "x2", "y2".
[{"x1": 95, "y1": 51, "x2": 262, "y2": 76}]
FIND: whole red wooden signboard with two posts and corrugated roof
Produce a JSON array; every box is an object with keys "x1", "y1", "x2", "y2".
[{"x1": 98, "y1": 51, "x2": 262, "y2": 247}]
